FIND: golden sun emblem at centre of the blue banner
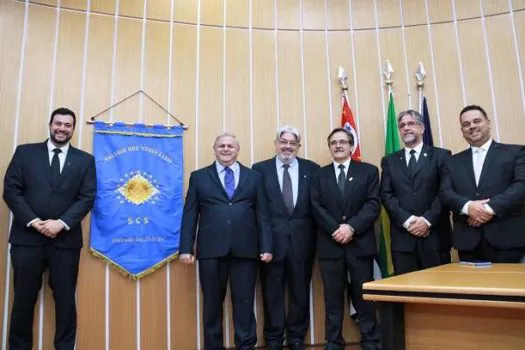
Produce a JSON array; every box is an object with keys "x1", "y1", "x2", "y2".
[{"x1": 116, "y1": 171, "x2": 160, "y2": 205}]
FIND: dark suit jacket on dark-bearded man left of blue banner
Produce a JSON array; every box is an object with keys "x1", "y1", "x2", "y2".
[{"x1": 4, "y1": 141, "x2": 97, "y2": 248}]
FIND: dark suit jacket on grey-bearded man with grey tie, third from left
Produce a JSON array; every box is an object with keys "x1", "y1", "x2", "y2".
[{"x1": 253, "y1": 157, "x2": 319, "y2": 261}]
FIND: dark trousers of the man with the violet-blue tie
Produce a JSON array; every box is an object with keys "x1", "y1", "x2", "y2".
[{"x1": 199, "y1": 256, "x2": 258, "y2": 349}]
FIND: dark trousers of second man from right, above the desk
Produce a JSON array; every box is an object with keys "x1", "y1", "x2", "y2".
[{"x1": 392, "y1": 239, "x2": 450, "y2": 275}]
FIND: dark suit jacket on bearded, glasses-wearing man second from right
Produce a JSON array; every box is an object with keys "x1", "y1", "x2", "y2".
[{"x1": 381, "y1": 145, "x2": 452, "y2": 252}]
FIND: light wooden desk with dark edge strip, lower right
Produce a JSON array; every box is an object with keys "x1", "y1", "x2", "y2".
[{"x1": 363, "y1": 263, "x2": 525, "y2": 350}]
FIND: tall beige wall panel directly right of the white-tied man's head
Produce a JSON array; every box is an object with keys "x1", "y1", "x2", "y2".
[{"x1": 485, "y1": 15, "x2": 525, "y2": 144}]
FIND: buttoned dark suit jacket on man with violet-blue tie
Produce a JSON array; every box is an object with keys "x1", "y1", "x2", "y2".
[{"x1": 180, "y1": 162, "x2": 272, "y2": 259}]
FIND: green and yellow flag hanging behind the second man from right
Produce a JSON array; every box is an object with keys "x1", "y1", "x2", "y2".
[{"x1": 379, "y1": 92, "x2": 401, "y2": 277}]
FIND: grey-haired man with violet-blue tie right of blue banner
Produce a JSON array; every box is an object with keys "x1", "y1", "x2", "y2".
[{"x1": 180, "y1": 133, "x2": 272, "y2": 350}]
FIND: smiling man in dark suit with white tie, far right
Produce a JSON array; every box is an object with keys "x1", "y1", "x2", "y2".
[{"x1": 441, "y1": 105, "x2": 525, "y2": 263}]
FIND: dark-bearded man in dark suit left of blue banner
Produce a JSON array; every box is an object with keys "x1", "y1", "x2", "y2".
[{"x1": 4, "y1": 108, "x2": 96, "y2": 350}]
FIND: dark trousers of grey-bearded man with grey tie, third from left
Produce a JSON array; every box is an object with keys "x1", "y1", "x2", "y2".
[{"x1": 261, "y1": 245, "x2": 313, "y2": 348}]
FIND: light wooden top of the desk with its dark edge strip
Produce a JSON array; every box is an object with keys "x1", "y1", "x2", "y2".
[{"x1": 363, "y1": 263, "x2": 525, "y2": 308}]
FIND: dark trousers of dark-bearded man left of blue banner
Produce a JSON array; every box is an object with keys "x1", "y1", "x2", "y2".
[{"x1": 9, "y1": 245, "x2": 80, "y2": 350}]
